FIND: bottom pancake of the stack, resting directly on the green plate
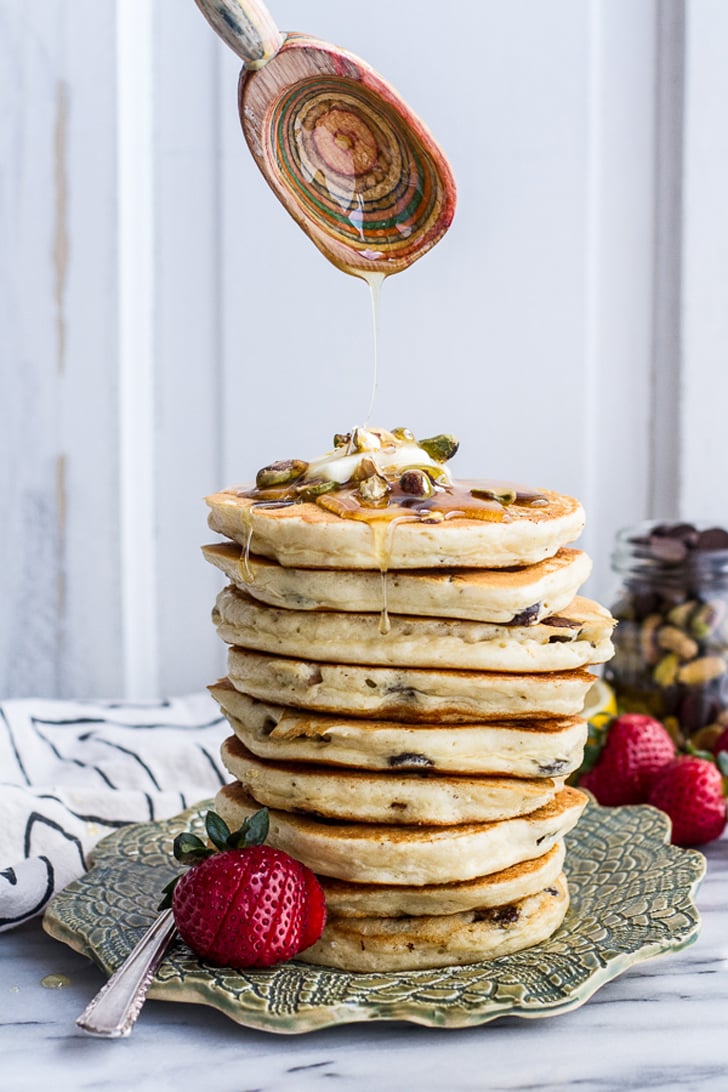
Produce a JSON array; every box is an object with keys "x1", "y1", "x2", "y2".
[{"x1": 297, "y1": 873, "x2": 569, "y2": 972}]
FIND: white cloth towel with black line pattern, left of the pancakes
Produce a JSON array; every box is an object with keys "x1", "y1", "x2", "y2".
[{"x1": 0, "y1": 693, "x2": 230, "y2": 930}]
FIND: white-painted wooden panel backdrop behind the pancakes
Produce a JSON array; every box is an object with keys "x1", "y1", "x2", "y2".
[{"x1": 0, "y1": 0, "x2": 728, "y2": 698}]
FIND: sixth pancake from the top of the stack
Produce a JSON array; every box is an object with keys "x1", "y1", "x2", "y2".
[{"x1": 220, "y1": 736, "x2": 563, "y2": 827}]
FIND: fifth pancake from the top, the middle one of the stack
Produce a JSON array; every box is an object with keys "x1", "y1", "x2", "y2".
[{"x1": 210, "y1": 679, "x2": 587, "y2": 778}]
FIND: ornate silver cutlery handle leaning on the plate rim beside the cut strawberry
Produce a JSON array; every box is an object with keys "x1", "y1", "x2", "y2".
[{"x1": 76, "y1": 910, "x2": 175, "y2": 1038}]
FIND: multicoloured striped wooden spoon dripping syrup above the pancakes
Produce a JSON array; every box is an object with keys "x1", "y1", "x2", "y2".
[{"x1": 196, "y1": 0, "x2": 455, "y2": 278}]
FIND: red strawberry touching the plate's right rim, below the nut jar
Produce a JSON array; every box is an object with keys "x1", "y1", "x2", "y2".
[{"x1": 647, "y1": 755, "x2": 726, "y2": 845}]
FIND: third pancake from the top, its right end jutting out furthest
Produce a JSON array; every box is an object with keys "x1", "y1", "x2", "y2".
[{"x1": 213, "y1": 586, "x2": 614, "y2": 673}]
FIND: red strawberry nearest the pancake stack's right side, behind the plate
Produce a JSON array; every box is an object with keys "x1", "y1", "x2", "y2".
[{"x1": 580, "y1": 713, "x2": 675, "y2": 806}]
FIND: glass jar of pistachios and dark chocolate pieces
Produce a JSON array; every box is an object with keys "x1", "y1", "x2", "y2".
[{"x1": 605, "y1": 522, "x2": 728, "y2": 749}]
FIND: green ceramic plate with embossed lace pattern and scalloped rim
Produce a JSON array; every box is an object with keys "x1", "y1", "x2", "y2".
[{"x1": 44, "y1": 802, "x2": 705, "y2": 1033}]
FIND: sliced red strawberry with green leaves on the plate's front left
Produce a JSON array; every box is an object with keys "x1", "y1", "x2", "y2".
[{"x1": 162, "y1": 808, "x2": 326, "y2": 968}]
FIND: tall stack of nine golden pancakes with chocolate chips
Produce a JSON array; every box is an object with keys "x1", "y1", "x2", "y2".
[{"x1": 204, "y1": 434, "x2": 612, "y2": 971}]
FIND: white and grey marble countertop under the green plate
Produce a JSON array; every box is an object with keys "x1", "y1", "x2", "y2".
[{"x1": 0, "y1": 836, "x2": 728, "y2": 1092}]
